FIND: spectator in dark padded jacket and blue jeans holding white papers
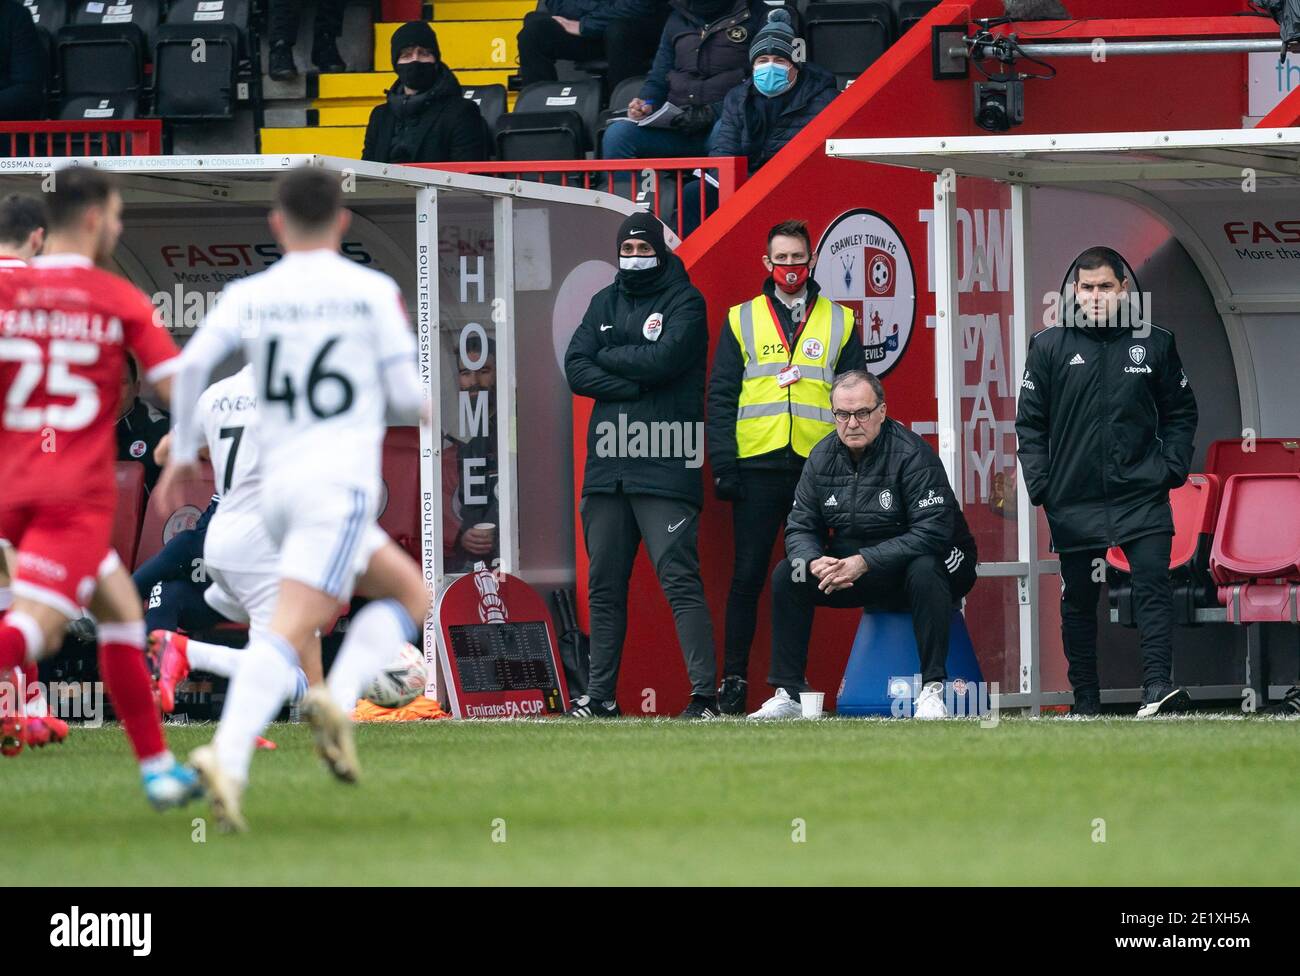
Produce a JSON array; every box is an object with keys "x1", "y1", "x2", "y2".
[{"x1": 601, "y1": 0, "x2": 767, "y2": 160}]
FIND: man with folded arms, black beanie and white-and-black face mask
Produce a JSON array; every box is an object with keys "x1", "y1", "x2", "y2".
[{"x1": 564, "y1": 213, "x2": 718, "y2": 719}]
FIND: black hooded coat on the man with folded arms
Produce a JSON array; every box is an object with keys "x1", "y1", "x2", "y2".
[{"x1": 564, "y1": 252, "x2": 709, "y2": 506}]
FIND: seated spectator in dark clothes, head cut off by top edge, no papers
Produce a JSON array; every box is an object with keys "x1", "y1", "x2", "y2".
[{"x1": 519, "y1": 0, "x2": 668, "y2": 88}]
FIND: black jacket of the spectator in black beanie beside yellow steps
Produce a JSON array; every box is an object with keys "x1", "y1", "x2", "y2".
[{"x1": 361, "y1": 61, "x2": 489, "y2": 162}]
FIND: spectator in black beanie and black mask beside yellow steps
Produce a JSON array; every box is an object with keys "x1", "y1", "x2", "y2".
[{"x1": 361, "y1": 21, "x2": 489, "y2": 162}]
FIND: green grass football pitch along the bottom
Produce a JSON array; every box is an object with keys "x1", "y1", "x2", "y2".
[{"x1": 0, "y1": 717, "x2": 1300, "y2": 886}]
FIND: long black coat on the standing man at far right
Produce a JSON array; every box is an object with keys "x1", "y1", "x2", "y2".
[{"x1": 1015, "y1": 324, "x2": 1196, "y2": 552}]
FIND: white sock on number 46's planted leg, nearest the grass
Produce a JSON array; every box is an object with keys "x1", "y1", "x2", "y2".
[{"x1": 214, "y1": 633, "x2": 298, "y2": 782}]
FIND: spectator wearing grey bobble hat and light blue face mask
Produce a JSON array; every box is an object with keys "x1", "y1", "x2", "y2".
[{"x1": 681, "y1": 8, "x2": 839, "y2": 237}]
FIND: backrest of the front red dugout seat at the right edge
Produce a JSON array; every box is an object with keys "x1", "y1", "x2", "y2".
[{"x1": 1210, "y1": 473, "x2": 1300, "y2": 584}]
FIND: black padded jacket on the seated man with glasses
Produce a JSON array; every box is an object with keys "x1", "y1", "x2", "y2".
[{"x1": 785, "y1": 417, "x2": 978, "y2": 573}]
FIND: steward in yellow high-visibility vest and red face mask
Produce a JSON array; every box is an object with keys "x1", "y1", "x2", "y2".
[{"x1": 709, "y1": 220, "x2": 867, "y2": 715}]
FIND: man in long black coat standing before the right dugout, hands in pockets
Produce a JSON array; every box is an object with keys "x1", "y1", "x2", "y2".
[{"x1": 1015, "y1": 247, "x2": 1196, "y2": 719}]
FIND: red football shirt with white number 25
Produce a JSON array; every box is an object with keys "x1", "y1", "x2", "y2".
[{"x1": 0, "y1": 255, "x2": 178, "y2": 508}]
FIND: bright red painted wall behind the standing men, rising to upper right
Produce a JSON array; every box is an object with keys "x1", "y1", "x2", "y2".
[{"x1": 575, "y1": 0, "x2": 1277, "y2": 713}]
